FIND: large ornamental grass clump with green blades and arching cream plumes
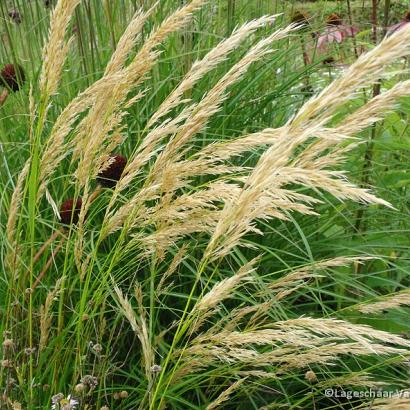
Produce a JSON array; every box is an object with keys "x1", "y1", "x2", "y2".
[{"x1": 4, "y1": 0, "x2": 410, "y2": 409}]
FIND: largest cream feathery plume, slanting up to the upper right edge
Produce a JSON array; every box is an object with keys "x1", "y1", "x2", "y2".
[{"x1": 200, "y1": 27, "x2": 410, "y2": 257}]
